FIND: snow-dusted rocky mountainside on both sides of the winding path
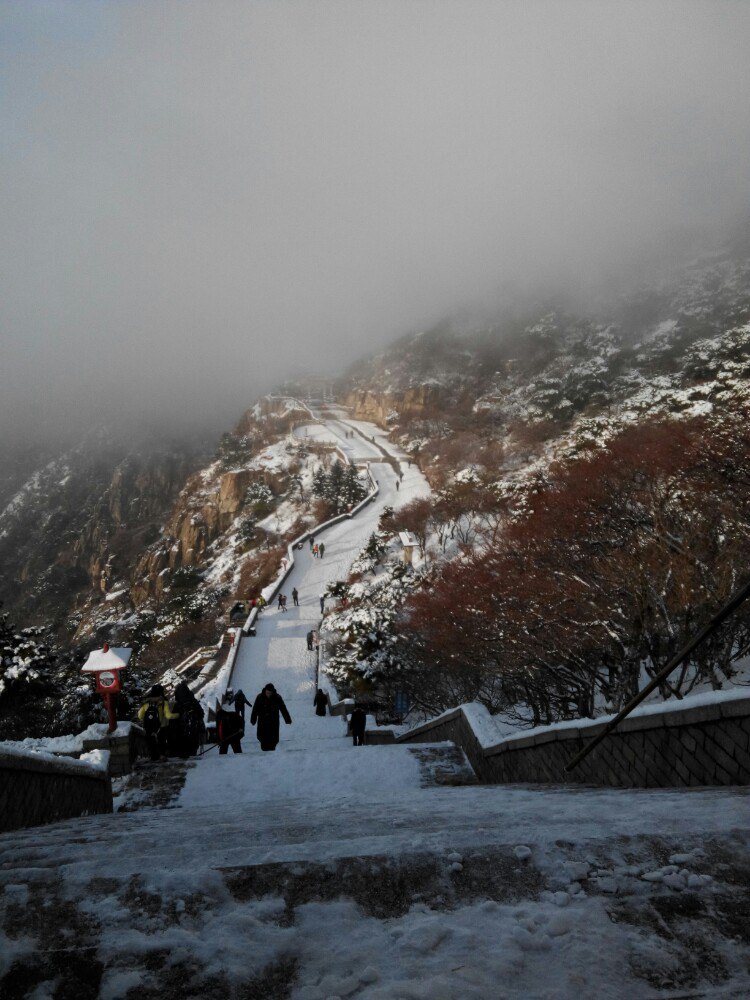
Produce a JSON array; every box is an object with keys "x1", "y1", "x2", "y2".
[{"x1": 0, "y1": 230, "x2": 750, "y2": 740}]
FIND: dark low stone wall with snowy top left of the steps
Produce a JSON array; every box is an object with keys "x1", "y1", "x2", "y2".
[{"x1": 0, "y1": 751, "x2": 112, "y2": 832}]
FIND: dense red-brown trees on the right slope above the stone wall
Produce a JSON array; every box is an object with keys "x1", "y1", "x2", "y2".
[{"x1": 404, "y1": 414, "x2": 750, "y2": 722}]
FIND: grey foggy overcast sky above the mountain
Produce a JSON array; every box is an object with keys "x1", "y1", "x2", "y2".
[{"x1": 0, "y1": 0, "x2": 750, "y2": 446}]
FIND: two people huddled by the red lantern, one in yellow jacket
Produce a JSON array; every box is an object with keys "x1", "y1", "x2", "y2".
[{"x1": 138, "y1": 681, "x2": 206, "y2": 761}]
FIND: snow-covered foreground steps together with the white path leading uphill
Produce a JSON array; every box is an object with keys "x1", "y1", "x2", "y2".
[{"x1": 0, "y1": 410, "x2": 750, "y2": 1000}]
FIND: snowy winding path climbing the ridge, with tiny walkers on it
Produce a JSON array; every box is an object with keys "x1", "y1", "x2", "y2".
[{"x1": 209, "y1": 406, "x2": 429, "y2": 788}]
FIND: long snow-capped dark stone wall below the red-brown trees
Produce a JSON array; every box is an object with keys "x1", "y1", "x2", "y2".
[{"x1": 398, "y1": 698, "x2": 750, "y2": 788}]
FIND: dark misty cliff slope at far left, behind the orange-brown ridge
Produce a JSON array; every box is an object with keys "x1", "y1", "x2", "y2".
[{"x1": 0, "y1": 435, "x2": 207, "y2": 623}]
